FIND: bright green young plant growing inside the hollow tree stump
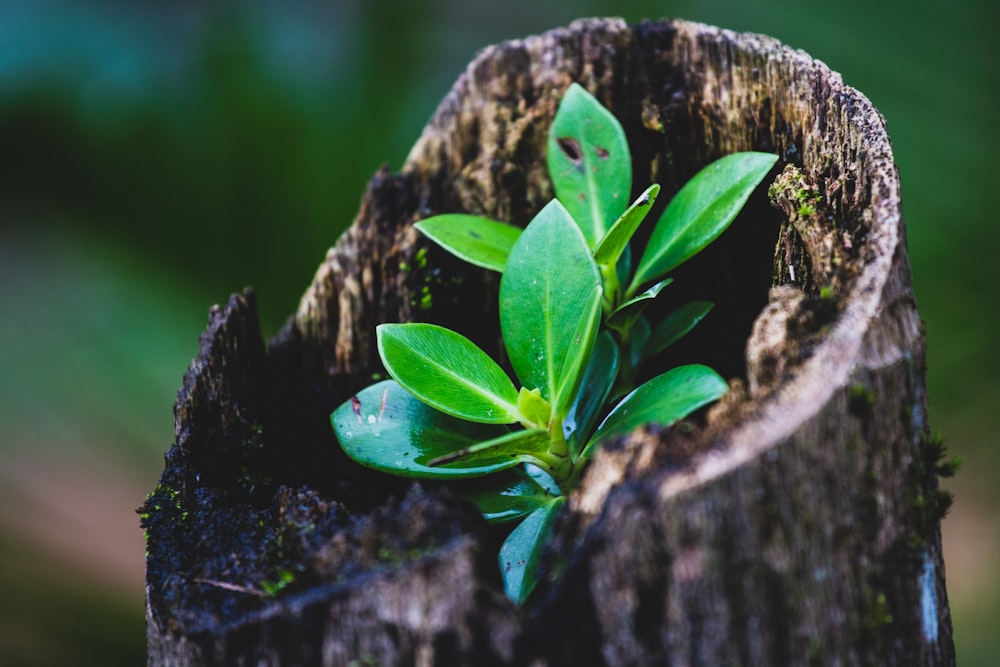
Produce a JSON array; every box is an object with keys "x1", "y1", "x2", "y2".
[{"x1": 331, "y1": 84, "x2": 777, "y2": 604}]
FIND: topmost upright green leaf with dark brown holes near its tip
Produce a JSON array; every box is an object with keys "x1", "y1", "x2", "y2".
[{"x1": 548, "y1": 83, "x2": 632, "y2": 248}]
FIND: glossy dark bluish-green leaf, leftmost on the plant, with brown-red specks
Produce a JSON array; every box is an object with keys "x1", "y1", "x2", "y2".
[{"x1": 330, "y1": 380, "x2": 521, "y2": 478}]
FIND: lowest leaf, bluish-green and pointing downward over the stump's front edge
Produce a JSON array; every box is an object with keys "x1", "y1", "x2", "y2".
[{"x1": 499, "y1": 497, "x2": 566, "y2": 605}]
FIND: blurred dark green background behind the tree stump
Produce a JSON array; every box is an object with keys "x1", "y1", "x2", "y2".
[{"x1": 0, "y1": 0, "x2": 1000, "y2": 665}]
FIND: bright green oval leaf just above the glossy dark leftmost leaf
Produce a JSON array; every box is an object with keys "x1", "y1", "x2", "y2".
[{"x1": 376, "y1": 323, "x2": 520, "y2": 424}]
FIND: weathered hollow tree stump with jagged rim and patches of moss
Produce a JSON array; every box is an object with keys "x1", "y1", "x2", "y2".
[{"x1": 141, "y1": 20, "x2": 954, "y2": 667}]
